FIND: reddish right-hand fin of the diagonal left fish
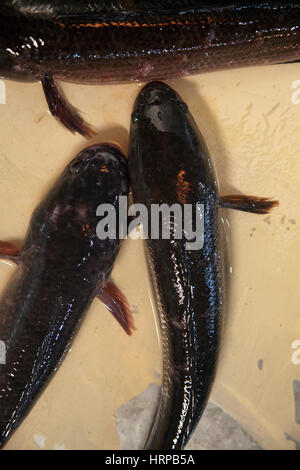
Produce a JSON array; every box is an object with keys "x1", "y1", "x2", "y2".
[{"x1": 97, "y1": 281, "x2": 135, "y2": 335}]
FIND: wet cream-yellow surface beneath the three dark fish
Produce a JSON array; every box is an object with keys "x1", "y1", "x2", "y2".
[{"x1": 0, "y1": 64, "x2": 300, "y2": 449}]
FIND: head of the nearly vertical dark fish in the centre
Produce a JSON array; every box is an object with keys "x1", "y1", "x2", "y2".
[{"x1": 128, "y1": 81, "x2": 216, "y2": 205}]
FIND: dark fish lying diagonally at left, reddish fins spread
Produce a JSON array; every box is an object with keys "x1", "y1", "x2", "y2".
[{"x1": 0, "y1": 144, "x2": 134, "y2": 447}]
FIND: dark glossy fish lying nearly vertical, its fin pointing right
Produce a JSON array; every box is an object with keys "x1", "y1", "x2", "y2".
[{"x1": 128, "y1": 81, "x2": 279, "y2": 450}]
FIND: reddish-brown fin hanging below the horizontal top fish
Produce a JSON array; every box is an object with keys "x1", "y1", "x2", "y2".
[{"x1": 42, "y1": 75, "x2": 95, "y2": 138}]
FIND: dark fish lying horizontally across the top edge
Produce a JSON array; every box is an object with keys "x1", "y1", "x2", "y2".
[{"x1": 0, "y1": 0, "x2": 300, "y2": 138}]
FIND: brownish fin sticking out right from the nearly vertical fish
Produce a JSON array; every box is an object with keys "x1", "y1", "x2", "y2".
[{"x1": 218, "y1": 194, "x2": 279, "y2": 214}]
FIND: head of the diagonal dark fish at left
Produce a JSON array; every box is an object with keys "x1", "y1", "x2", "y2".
[{"x1": 31, "y1": 144, "x2": 129, "y2": 250}]
